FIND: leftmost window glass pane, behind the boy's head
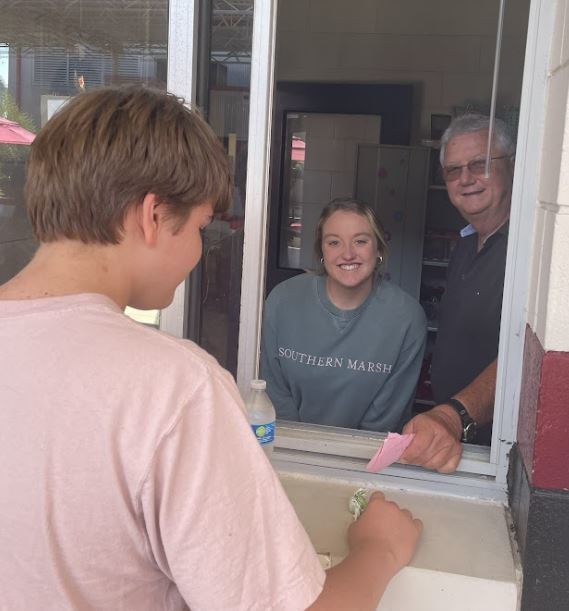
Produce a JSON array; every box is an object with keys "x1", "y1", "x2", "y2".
[{"x1": 0, "y1": 0, "x2": 168, "y2": 324}]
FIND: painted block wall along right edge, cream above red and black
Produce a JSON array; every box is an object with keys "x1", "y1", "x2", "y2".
[{"x1": 510, "y1": 0, "x2": 569, "y2": 611}]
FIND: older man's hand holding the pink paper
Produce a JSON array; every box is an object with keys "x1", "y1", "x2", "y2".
[{"x1": 399, "y1": 403, "x2": 462, "y2": 473}]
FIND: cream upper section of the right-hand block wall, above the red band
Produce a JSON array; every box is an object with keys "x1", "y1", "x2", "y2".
[{"x1": 528, "y1": 0, "x2": 569, "y2": 352}]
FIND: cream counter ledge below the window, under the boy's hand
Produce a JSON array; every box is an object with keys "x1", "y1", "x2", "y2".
[{"x1": 275, "y1": 470, "x2": 521, "y2": 611}]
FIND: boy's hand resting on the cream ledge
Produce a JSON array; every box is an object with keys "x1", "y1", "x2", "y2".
[{"x1": 348, "y1": 492, "x2": 423, "y2": 574}]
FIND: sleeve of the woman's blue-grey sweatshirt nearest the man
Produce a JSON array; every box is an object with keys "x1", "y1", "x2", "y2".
[{"x1": 360, "y1": 306, "x2": 427, "y2": 432}]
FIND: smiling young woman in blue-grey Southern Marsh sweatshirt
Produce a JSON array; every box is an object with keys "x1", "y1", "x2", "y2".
[{"x1": 261, "y1": 199, "x2": 426, "y2": 431}]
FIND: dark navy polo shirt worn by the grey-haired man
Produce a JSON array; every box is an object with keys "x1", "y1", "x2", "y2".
[{"x1": 431, "y1": 223, "x2": 509, "y2": 403}]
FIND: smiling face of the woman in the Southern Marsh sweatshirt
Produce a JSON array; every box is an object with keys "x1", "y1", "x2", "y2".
[{"x1": 322, "y1": 210, "x2": 378, "y2": 295}]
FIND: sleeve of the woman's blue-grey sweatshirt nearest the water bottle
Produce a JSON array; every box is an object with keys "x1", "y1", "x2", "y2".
[{"x1": 260, "y1": 294, "x2": 300, "y2": 422}]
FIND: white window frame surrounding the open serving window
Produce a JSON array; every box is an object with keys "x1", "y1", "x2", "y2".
[{"x1": 160, "y1": 0, "x2": 557, "y2": 501}]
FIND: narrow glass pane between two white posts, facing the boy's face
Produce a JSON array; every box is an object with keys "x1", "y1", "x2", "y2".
[{"x1": 199, "y1": 0, "x2": 253, "y2": 375}]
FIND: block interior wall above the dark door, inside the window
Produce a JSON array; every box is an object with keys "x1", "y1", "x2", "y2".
[{"x1": 276, "y1": 0, "x2": 530, "y2": 144}]
